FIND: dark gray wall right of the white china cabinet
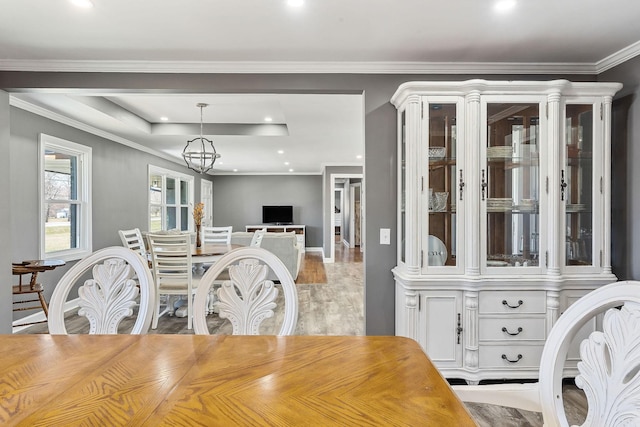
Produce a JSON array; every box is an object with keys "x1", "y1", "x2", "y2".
[{"x1": 598, "y1": 56, "x2": 640, "y2": 280}]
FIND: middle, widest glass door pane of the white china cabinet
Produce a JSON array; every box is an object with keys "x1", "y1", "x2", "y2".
[{"x1": 480, "y1": 102, "x2": 540, "y2": 268}]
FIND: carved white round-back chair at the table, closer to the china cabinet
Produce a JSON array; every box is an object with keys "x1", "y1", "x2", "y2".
[{"x1": 193, "y1": 246, "x2": 298, "y2": 335}]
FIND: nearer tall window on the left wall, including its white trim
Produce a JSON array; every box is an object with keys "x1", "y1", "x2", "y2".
[{"x1": 39, "y1": 134, "x2": 92, "y2": 261}]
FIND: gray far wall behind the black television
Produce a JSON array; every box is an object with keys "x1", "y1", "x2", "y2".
[{"x1": 213, "y1": 175, "x2": 322, "y2": 248}]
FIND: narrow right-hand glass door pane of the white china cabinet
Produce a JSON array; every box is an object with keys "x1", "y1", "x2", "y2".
[{"x1": 561, "y1": 104, "x2": 594, "y2": 266}]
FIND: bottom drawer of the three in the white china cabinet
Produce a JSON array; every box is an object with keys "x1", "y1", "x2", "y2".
[{"x1": 478, "y1": 344, "x2": 543, "y2": 369}]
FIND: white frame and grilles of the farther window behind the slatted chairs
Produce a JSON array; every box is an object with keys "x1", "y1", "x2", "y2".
[{"x1": 146, "y1": 164, "x2": 195, "y2": 232}]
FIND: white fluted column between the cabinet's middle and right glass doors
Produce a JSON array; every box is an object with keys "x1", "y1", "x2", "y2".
[{"x1": 541, "y1": 93, "x2": 565, "y2": 276}]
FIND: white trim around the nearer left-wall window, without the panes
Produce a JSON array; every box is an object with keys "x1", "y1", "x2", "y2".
[{"x1": 38, "y1": 134, "x2": 93, "y2": 261}]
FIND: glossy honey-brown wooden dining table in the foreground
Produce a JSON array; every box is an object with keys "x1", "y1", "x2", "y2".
[{"x1": 0, "y1": 335, "x2": 475, "y2": 427}]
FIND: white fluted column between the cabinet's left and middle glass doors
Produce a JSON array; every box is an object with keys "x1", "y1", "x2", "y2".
[{"x1": 464, "y1": 90, "x2": 482, "y2": 276}]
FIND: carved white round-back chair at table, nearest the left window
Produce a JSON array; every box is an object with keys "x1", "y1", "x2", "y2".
[{"x1": 48, "y1": 246, "x2": 155, "y2": 335}]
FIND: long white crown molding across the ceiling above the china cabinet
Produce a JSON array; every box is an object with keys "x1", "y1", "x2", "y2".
[{"x1": 0, "y1": 59, "x2": 596, "y2": 74}]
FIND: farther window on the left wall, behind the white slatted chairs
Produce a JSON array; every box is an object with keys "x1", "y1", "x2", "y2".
[{"x1": 149, "y1": 165, "x2": 193, "y2": 231}]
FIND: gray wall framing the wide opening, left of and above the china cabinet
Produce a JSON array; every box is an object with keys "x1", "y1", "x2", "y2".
[{"x1": 0, "y1": 71, "x2": 595, "y2": 335}]
